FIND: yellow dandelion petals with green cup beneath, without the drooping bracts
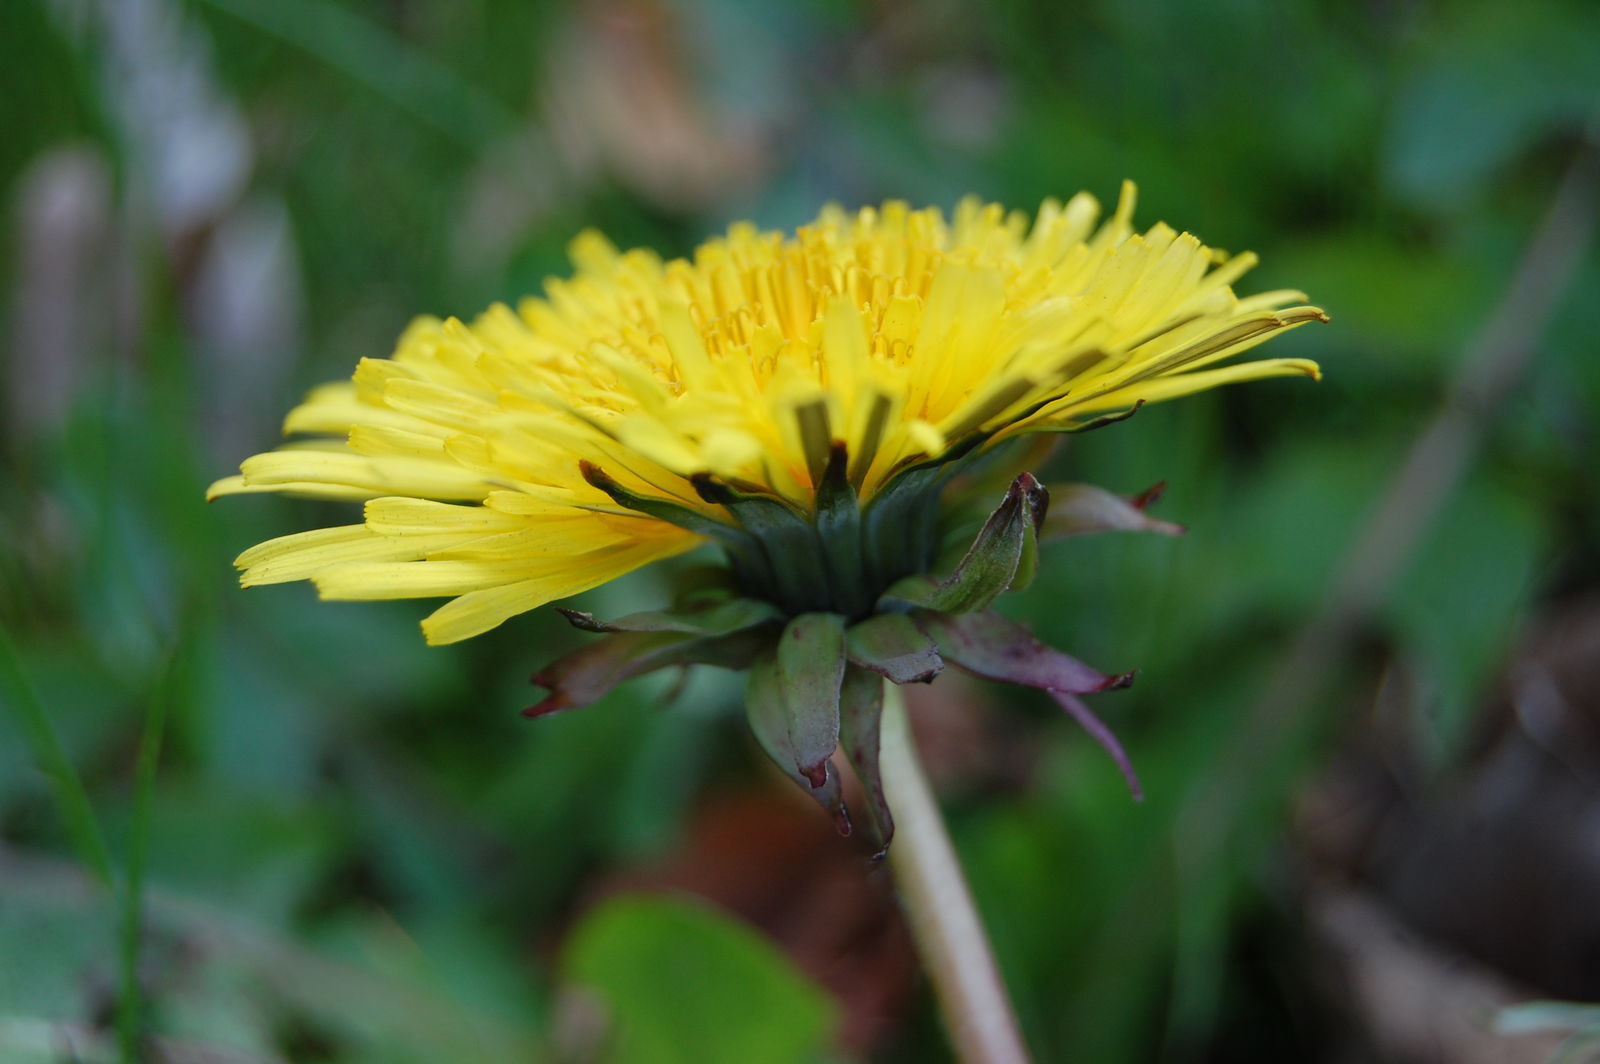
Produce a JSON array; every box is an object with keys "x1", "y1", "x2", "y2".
[{"x1": 211, "y1": 186, "x2": 1326, "y2": 643}]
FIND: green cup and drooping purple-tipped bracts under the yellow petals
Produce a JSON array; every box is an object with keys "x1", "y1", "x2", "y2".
[{"x1": 526, "y1": 460, "x2": 1182, "y2": 856}]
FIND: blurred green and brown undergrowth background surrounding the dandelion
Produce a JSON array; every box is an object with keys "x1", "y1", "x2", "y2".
[{"x1": 0, "y1": 0, "x2": 1600, "y2": 1064}]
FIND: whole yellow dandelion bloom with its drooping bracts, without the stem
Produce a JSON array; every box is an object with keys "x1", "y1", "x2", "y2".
[{"x1": 211, "y1": 184, "x2": 1326, "y2": 846}]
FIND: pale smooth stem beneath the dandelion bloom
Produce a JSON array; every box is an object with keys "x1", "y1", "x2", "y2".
[{"x1": 878, "y1": 683, "x2": 1027, "y2": 1064}]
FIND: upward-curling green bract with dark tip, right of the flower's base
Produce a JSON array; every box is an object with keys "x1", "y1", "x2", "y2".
[{"x1": 880, "y1": 474, "x2": 1050, "y2": 613}]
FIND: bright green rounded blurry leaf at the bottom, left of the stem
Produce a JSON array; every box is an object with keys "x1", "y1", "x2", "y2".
[{"x1": 563, "y1": 896, "x2": 837, "y2": 1064}]
